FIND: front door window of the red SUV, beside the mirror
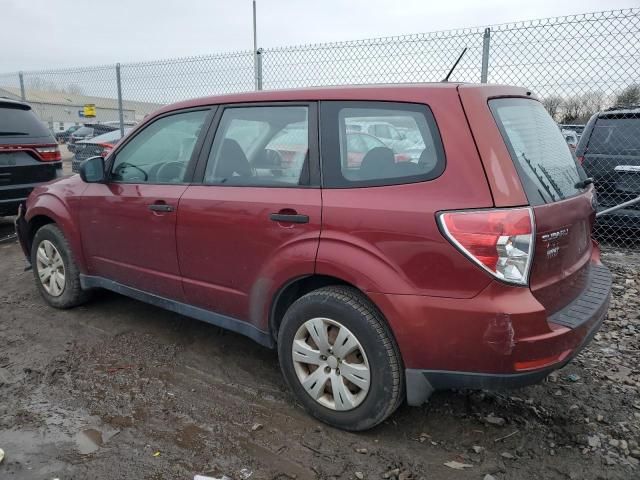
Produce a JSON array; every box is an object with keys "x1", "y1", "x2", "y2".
[{"x1": 111, "y1": 110, "x2": 208, "y2": 183}]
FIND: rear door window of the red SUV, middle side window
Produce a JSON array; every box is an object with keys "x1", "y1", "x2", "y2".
[{"x1": 205, "y1": 106, "x2": 309, "y2": 186}]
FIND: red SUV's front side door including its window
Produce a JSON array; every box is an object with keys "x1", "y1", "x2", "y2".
[{"x1": 79, "y1": 109, "x2": 211, "y2": 300}]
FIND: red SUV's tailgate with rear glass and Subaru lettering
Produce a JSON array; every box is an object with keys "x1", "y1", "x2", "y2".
[{"x1": 460, "y1": 87, "x2": 595, "y2": 315}]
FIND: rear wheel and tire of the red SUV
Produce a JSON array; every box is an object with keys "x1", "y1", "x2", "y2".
[{"x1": 278, "y1": 286, "x2": 404, "y2": 431}]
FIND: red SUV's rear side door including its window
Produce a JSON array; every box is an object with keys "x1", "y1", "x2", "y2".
[{"x1": 177, "y1": 103, "x2": 321, "y2": 335}]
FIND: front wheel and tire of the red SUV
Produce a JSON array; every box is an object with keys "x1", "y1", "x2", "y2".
[{"x1": 31, "y1": 224, "x2": 90, "y2": 309}]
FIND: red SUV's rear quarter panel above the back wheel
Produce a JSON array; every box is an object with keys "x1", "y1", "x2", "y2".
[{"x1": 316, "y1": 88, "x2": 493, "y2": 298}]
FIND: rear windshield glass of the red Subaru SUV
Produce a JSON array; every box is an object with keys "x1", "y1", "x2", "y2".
[{"x1": 489, "y1": 98, "x2": 581, "y2": 205}]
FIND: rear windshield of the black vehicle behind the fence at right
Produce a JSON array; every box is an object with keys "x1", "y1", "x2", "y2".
[{"x1": 587, "y1": 116, "x2": 640, "y2": 155}]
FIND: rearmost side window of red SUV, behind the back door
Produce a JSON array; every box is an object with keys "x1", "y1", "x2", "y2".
[{"x1": 321, "y1": 102, "x2": 445, "y2": 188}]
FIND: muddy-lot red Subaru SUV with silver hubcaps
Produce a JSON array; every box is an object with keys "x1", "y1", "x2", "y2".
[{"x1": 17, "y1": 83, "x2": 611, "y2": 430}]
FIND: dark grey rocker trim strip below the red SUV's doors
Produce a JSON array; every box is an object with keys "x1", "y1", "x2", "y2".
[{"x1": 80, "y1": 274, "x2": 275, "y2": 348}]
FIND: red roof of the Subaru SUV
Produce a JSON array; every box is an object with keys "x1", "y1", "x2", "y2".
[{"x1": 150, "y1": 82, "x2": 530, "y2": 117}]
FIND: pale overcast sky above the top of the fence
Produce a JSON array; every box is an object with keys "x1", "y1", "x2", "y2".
[{"x1": 0, "y1": 0, "x2": 639, "y2": 73}]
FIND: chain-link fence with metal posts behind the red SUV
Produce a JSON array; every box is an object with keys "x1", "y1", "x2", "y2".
[{"x1": 0, "y1": 8, "x2": 640, "y2": 247}]
